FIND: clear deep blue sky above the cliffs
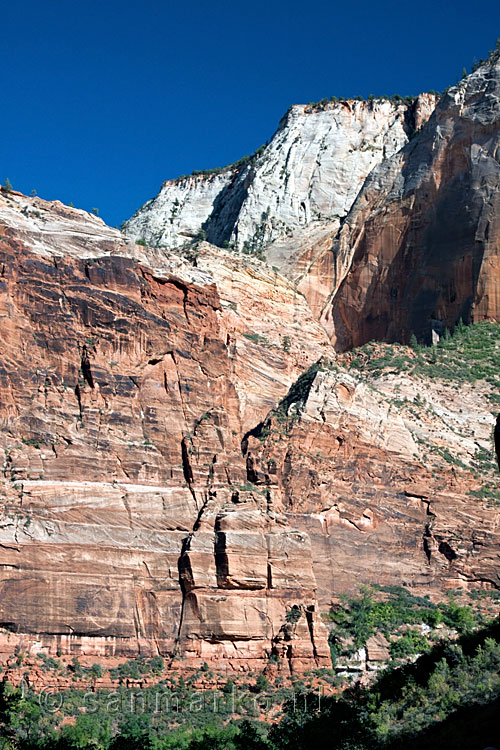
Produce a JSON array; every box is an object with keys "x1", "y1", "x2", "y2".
[{"x1": 0, "y1": 0, "x2": 500, "y2": 225}]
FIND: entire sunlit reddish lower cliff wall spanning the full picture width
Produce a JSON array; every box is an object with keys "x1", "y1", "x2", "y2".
[{"x1": 0, "y1": 188, "x2": 500, "y2": 673}]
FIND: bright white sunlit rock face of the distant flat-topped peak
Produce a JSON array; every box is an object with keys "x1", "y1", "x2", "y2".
[{"x1": 213, "y1": 97, "x2": 433, "y2": 253}]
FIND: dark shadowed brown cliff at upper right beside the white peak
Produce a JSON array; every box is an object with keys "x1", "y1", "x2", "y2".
[{"x1": 322, "y1": 54, "x2": 500, "y2": 349}]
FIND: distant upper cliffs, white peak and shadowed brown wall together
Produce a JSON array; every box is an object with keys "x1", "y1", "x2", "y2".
[{"x1": 126, "y1": 58, "x2": 500, "y2": 351}]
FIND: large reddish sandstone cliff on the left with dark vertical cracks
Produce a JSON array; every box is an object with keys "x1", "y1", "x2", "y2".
[{"x1": 0, "y1": 194, "x2": 328, "y2": 669}]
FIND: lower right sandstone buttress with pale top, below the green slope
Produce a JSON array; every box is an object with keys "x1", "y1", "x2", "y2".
[{"x1": 248, "y1": 366, "x2": 500, "y2": 608}]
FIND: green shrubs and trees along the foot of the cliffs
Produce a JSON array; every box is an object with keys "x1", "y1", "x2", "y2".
[{"x1": 0, "y1": 621, "x2": 500, "y2": 750}]
